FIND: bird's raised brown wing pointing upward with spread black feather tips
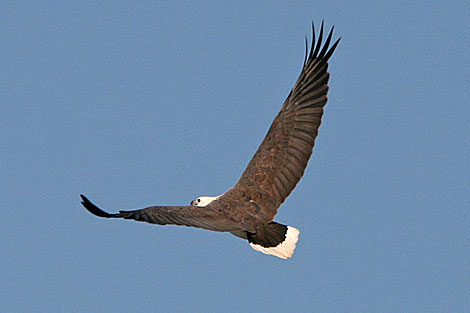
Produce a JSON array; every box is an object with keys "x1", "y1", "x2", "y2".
[{"x1": 227, "y1": 22, "x2": 341, "y2": 220}]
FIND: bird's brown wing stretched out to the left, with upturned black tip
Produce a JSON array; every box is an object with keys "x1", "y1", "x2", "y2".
[{"x1": 80, "y1": 195, "x2": 240, "y2": 232}]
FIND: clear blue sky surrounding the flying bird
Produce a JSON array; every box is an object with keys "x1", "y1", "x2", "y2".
[{"x1": 0, "y1": 1, "x2": 470, "y2": 312}]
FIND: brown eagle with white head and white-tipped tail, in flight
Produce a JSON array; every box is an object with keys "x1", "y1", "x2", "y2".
[{"x1": 80, "y1": 22, "x2": 341, "y2": 259}]
